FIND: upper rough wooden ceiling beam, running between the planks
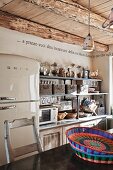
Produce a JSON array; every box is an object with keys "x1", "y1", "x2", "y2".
[{"x1": 24, "y1": 0, "x2": 113, "y2": 37}]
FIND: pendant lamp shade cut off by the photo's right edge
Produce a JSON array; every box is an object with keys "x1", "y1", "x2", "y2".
[{"x1": 102, "y1": 8, "x2": 113, "y2": 29}]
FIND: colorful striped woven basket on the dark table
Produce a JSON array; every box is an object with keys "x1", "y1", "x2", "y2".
[{"x1": 66, "y1": 127, "x2": 113, "y2": 164}]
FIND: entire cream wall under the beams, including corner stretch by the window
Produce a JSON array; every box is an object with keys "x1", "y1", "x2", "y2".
[{"x1": 0, "y1": 27, "x2": 113, "y2": 112}]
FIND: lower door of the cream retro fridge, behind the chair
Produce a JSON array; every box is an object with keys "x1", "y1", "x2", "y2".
[{"x1": 0, "y1": 102, "x2": 39, "y2": 165}]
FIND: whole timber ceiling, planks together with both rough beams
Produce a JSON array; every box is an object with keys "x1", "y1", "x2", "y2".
[{"x1": 0, "y1": 0, "x2": 113, "y2": 51}]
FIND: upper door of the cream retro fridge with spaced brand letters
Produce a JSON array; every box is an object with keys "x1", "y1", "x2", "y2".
[{"x1": 0, "y1": 55, "x2": 39, "y2": 102}]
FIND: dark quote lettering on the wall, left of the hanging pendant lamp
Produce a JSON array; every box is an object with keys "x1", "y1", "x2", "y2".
[{"x1": 17, "y1": 40, "x2": 88, "y2": 57}]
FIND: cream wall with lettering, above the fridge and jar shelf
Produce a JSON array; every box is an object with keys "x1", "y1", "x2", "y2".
[{"x1": 0, "y1": 27, "x2": 92, "y2": 68}]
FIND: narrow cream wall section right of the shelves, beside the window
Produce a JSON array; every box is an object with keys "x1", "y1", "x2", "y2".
[{"x1": 93, "y1": 45, "x2": 113, "y2": 114}]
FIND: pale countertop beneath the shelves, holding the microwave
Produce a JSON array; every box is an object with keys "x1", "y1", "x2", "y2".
[{"x1": 39, "y1": 115, "x2": 107, "y2": 130}]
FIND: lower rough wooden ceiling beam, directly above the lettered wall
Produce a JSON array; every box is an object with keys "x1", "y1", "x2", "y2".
[{"x1": 0, "y1": 11, "x2": 109, "y2": 51}]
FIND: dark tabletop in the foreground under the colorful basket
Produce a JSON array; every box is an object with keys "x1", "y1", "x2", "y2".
[{"x1": 0, "y1": 144, "x2": 113, "y2": 170}]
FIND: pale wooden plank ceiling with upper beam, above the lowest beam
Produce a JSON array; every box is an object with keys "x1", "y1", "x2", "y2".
[{"x1": 0, "y1": 0, "x2": 113, "y2": 51}]
